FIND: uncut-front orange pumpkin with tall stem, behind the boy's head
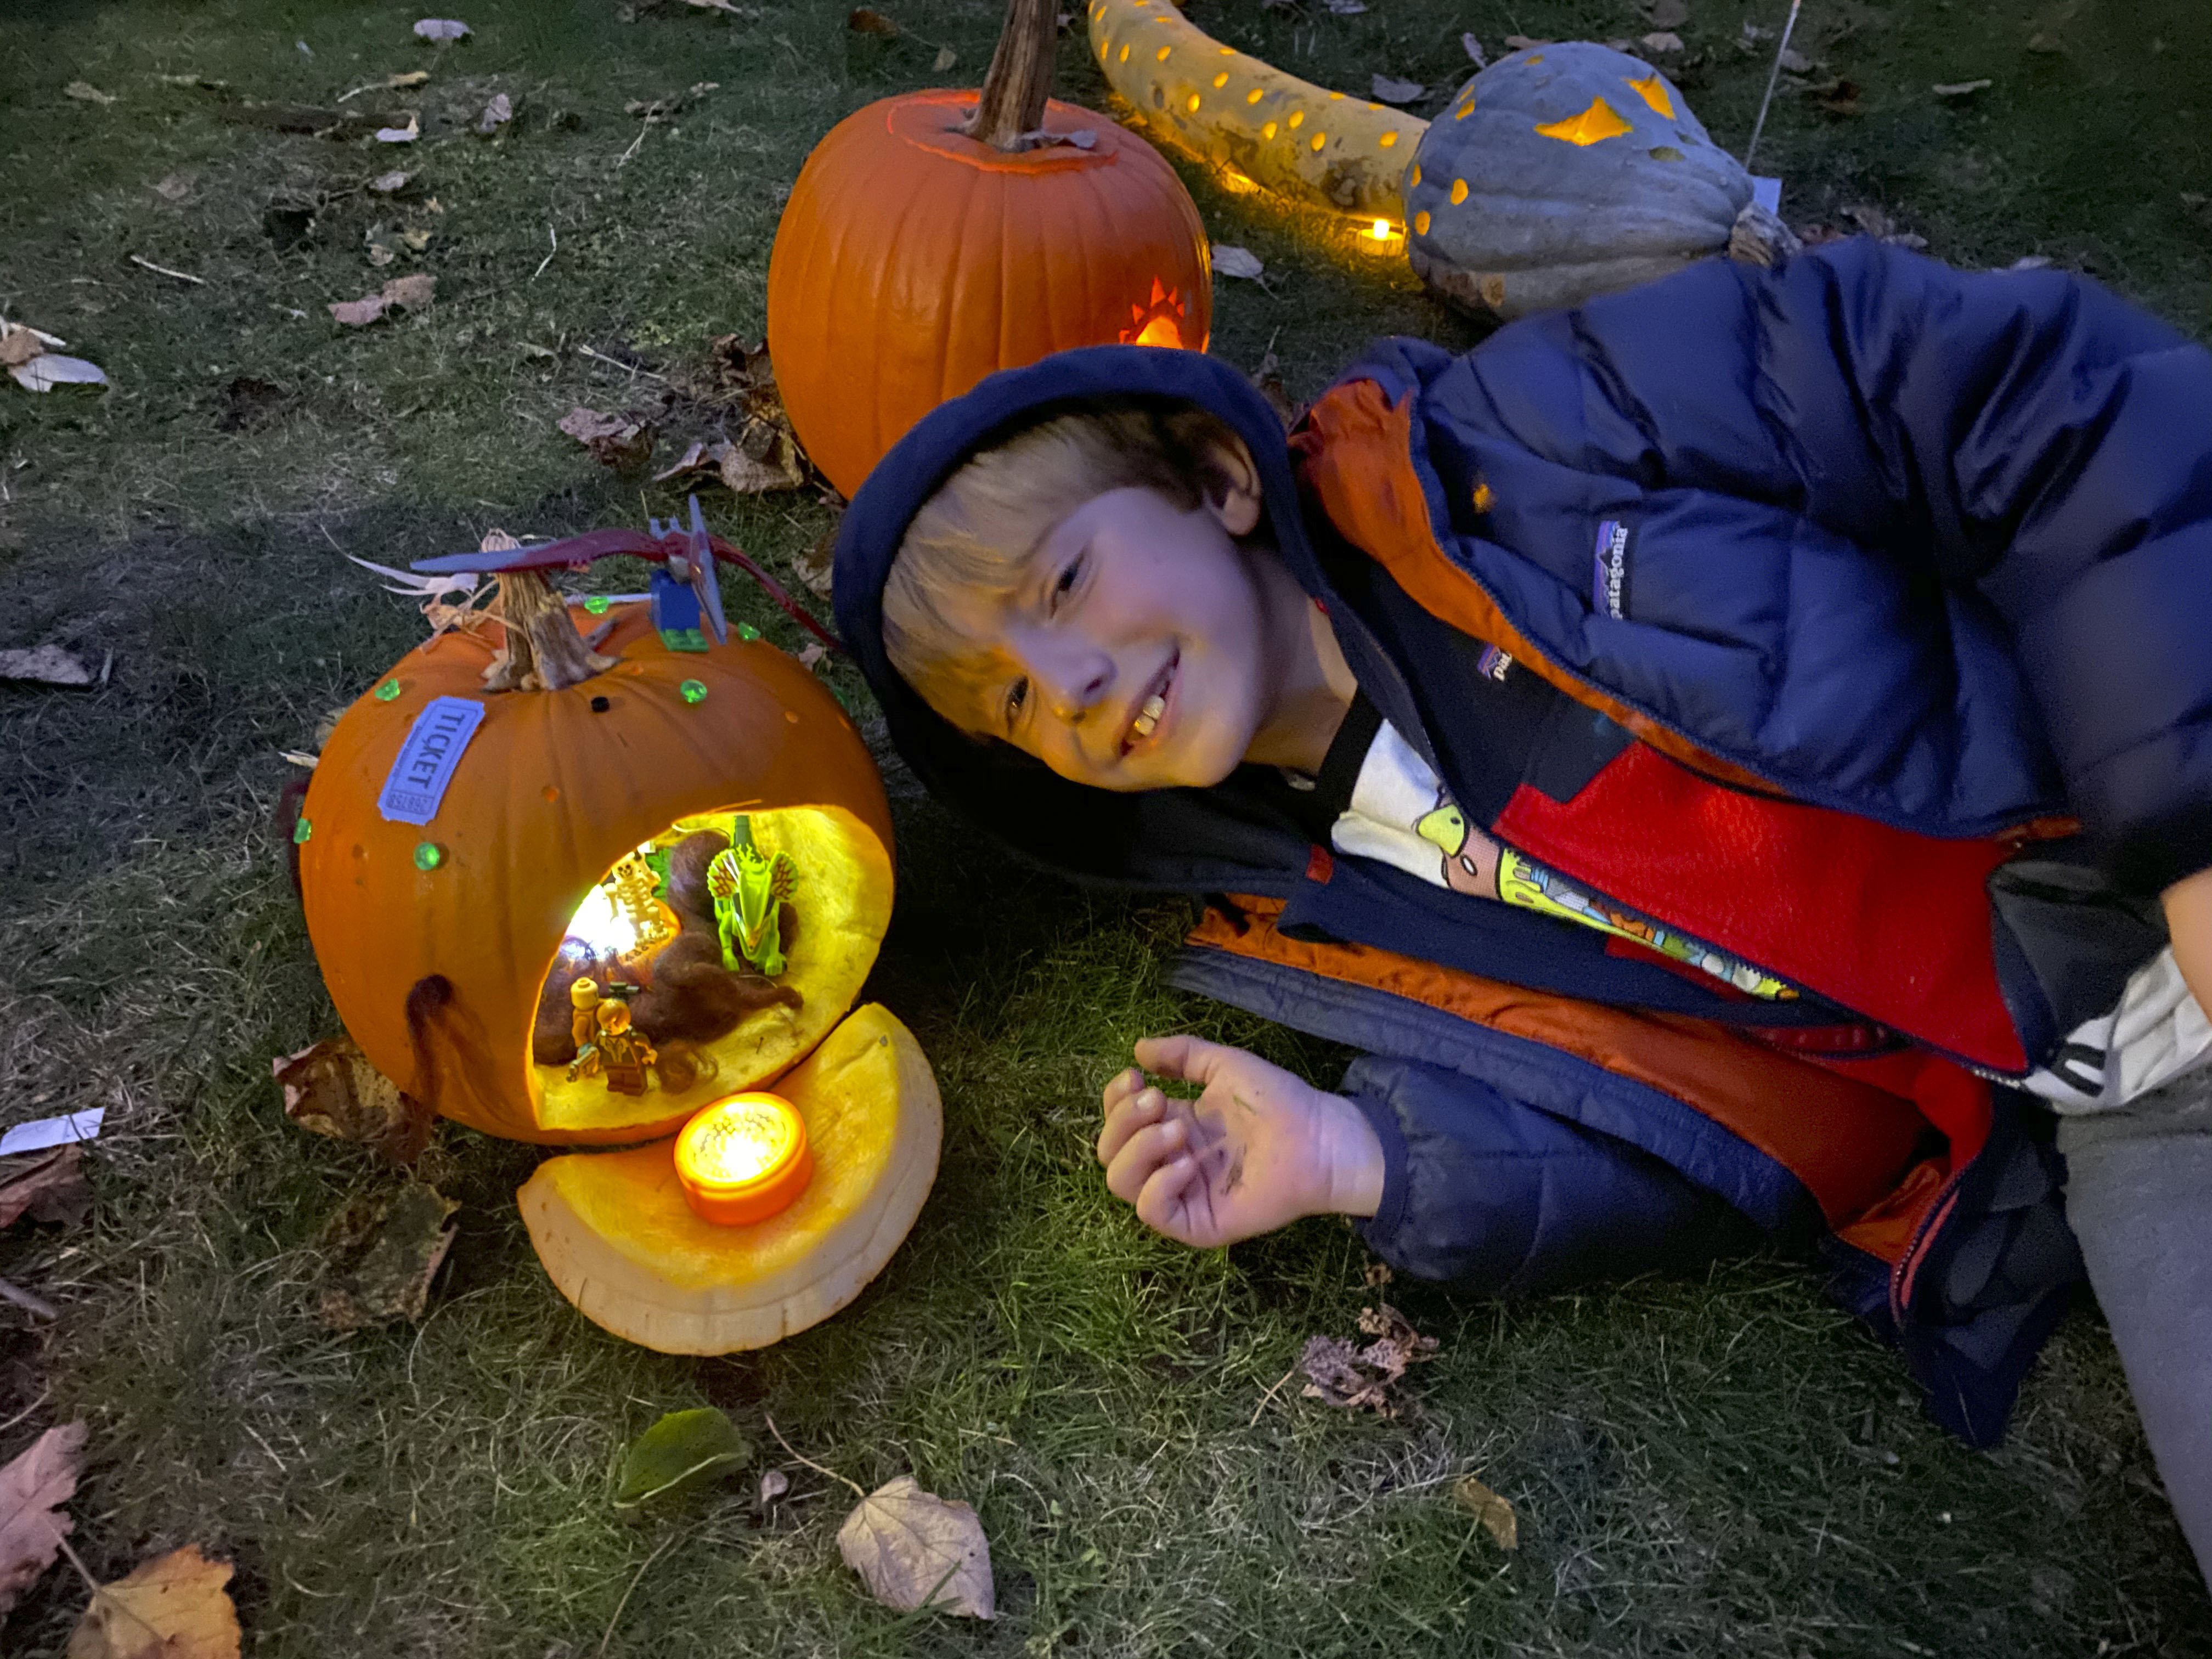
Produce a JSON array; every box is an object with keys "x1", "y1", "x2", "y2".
[{"x1": 768, "y1": 0, "x2": 1212, "y2": 495}]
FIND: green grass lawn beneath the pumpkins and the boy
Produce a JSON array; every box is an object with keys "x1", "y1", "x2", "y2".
[{"x1": 0, "y1": 0, "x2": 2212, "y2": 1659}]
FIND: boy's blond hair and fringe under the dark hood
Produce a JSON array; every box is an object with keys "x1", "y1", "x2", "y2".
[{"x1": 883, "y1": 403, "x2": 1241, "y2": 712}]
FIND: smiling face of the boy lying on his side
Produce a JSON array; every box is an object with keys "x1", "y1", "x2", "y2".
[{"x1": 938, "y1": 489, "x2": 1305, "y2": 789}]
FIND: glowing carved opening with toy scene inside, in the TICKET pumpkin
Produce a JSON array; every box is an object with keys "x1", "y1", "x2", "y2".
[{"x1": 527, "y1": 808, "x2": 891, "y2": 1137}]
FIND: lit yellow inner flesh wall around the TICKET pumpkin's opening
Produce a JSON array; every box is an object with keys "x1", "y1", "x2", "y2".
[{"x1": 524, "y1": 808, "x2": 891, "y2": 1137}]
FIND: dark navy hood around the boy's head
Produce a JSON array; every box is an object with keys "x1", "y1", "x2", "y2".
[{"x1": 834, "y1": 345, "x2": 1323, "y2": 894}]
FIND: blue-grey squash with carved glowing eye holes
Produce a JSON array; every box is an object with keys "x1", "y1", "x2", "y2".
[{"x1": 1404, "y1": 40, "x2": 1752, "y2": 317}]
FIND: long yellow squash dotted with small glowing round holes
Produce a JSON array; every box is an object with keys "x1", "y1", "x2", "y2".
[{"x1": 1091, "y1": 0, "x2": 1429, "y2": 231}]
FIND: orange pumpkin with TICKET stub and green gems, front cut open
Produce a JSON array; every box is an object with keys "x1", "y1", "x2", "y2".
[{"x1": 296, "y1": 579, "x2": 891, "y2": 1144}]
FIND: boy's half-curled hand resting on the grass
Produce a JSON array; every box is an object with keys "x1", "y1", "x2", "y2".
[{"x1": 1099, "y1": 1037, "x2": 1383, "y2": 1250}]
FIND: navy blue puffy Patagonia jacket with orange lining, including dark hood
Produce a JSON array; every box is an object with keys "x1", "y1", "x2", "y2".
[{"x1": 836, "y1": 241, "x2": 2212, "y2": 1444}]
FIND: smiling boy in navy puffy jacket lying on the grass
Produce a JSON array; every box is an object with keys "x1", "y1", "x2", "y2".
[{"x1": 836, "y1": 241, "x2": 2212, "y2": 1564}]
